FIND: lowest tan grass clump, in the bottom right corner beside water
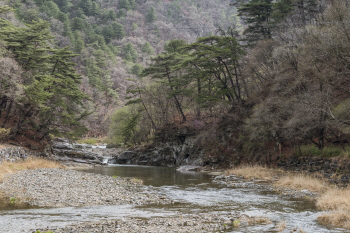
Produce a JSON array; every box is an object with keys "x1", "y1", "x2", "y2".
[{"x1": 317, "y1": 210, "x2": 350, "y2": 229}]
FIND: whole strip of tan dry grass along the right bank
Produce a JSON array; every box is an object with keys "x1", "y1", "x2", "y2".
[{"x1": 226, "y1": 165, "x2": 350, "y2": 229}]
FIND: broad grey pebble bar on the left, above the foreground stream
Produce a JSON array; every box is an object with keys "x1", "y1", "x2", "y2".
[{"x1": 0, "y1": 169, "x2": 171, "y2": 207}]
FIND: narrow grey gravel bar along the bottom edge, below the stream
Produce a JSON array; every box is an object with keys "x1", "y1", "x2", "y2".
[{"x1": 33, "y1": 213, "x2": 271, "y2": 233}]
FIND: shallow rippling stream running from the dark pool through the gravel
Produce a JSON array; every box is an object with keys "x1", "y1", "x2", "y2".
[{"x1": 0, "y1": 166, "x2": 348, "y2": 233}]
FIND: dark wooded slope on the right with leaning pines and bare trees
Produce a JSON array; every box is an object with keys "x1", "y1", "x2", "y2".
[{"x1": 110, "y1": 0, "x2": 350, "y2": 160}]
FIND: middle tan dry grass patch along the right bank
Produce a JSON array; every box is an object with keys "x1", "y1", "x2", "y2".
[{"x1": 274, "y1": 175, "x2": 327, "y2": 192}]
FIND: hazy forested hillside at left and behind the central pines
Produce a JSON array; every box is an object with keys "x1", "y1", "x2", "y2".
[{"x1": 0, "y1": 0, "x2": 240, "y2": 140}]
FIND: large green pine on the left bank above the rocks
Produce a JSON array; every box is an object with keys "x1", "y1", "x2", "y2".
[{"x1": 0, "y1": 21, "x2": 87, "y2": 138}]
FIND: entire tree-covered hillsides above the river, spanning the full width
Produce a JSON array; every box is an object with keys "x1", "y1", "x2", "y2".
[{"x1": 0, "y1": 0, "x2": 350, "y2": 160}]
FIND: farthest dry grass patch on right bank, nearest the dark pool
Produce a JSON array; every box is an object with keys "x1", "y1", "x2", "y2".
[{"x1": 226, "y1": 165, "x2": 281, "y2": 181}]
